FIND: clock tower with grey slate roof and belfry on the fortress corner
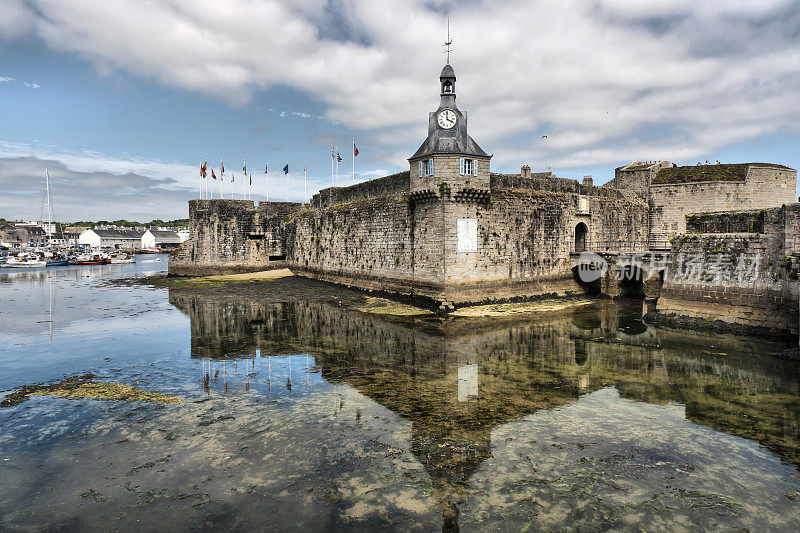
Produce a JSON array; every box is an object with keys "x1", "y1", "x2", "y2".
[{"x1": 408, "y1": 62, "x2": 491, "y2": 200}]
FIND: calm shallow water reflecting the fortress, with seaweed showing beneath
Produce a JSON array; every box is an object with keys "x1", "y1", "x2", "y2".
[{"x1": 0, "y1": 258, "x2": 800, "y2": 531}]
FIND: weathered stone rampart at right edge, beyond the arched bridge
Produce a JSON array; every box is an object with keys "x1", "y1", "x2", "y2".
[{"x1": 657, "y1": 204, "x2": 800, "y2": 335}]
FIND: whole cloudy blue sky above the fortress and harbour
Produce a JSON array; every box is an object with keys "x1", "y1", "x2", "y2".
[{"x1": 0, "y1": 0, "x2": 800, "y2": 220}]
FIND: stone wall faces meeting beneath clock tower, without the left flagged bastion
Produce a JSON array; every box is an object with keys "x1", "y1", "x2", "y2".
[{"x1": 287, "y1": 170, "x2": 647, "y2": 302}]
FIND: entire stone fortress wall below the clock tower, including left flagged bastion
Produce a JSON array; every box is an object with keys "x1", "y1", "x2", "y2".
[{"x1": 170, "y1": 173, "x2": 647, "y2": 302}]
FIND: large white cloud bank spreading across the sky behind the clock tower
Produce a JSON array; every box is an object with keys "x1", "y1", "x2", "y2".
[{"x1": 0, "y1": 0, "x2": 800, "y2": 179}]
